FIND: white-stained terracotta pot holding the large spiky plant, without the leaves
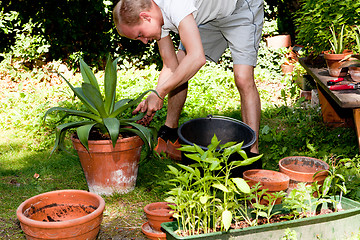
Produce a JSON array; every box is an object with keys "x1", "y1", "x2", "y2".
[{"x1": 71, "y1": 136, "x2": 143, "y2": 195}]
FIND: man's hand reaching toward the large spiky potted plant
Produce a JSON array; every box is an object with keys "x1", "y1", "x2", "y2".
[{"x1": 133, "y1": 92, "x2": 164, "y2": 126}]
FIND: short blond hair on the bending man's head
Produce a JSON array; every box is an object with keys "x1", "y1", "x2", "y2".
[{"x1": 113, "y1": 0, "x2": 152, "y2": 27}]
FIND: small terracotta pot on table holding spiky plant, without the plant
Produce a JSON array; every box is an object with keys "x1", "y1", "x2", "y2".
[{"x1": 324, "y1": 50, "x2": 352, "y2": 77}]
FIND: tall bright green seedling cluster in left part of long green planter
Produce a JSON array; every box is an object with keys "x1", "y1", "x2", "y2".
[{"x1": 166, "y1": 135, "x2": 261, "y2": 234}]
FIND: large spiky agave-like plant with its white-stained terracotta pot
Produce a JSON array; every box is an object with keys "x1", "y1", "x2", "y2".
[{"x1": 45, "y1": 57, "x2": 157, "y2": 195}]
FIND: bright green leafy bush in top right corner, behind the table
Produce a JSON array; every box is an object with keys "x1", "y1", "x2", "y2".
[{"x1": 295, "y1": 0, "x2": 360, "y2": 54}]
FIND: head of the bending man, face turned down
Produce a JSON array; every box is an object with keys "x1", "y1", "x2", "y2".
[{"x1": 113, "y1": 0, "x2": 163, "y2": 44}]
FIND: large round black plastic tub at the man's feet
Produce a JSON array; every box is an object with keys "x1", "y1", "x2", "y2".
[{"x1": 178, "y1": 115, "x2": 262, "y2": 177}]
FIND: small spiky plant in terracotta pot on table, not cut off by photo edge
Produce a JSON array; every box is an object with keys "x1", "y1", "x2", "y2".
[{"x1": 324, "y1": 25, "x2": 352, "y2": 77}]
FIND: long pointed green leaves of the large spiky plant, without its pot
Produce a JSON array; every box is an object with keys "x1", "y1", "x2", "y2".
[{"x1": 44, "y1": 57, "x2": 157, "y2": 158}]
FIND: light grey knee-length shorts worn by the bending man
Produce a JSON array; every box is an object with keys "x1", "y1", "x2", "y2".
[{"x1": 179, "y1": 0, "x2": 264, "y2": 66}]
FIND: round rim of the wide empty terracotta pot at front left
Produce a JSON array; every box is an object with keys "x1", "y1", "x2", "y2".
[{"x1": 16, "y1": 189, "x2": 105, "y2": 229}]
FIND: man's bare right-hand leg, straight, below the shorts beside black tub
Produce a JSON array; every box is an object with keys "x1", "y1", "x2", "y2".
[{"x1": 234, "y1": 64, "x2": 261, "y2": 153}]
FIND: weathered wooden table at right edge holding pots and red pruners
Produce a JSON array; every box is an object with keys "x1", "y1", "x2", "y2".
[{"x1": 299, "y1": 58, "x2": 360, "y2": 149}]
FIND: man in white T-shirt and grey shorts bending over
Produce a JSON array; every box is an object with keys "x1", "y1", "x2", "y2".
[{"x1": 113, "y1": 0, "x2": 264, "y2": 153}]
